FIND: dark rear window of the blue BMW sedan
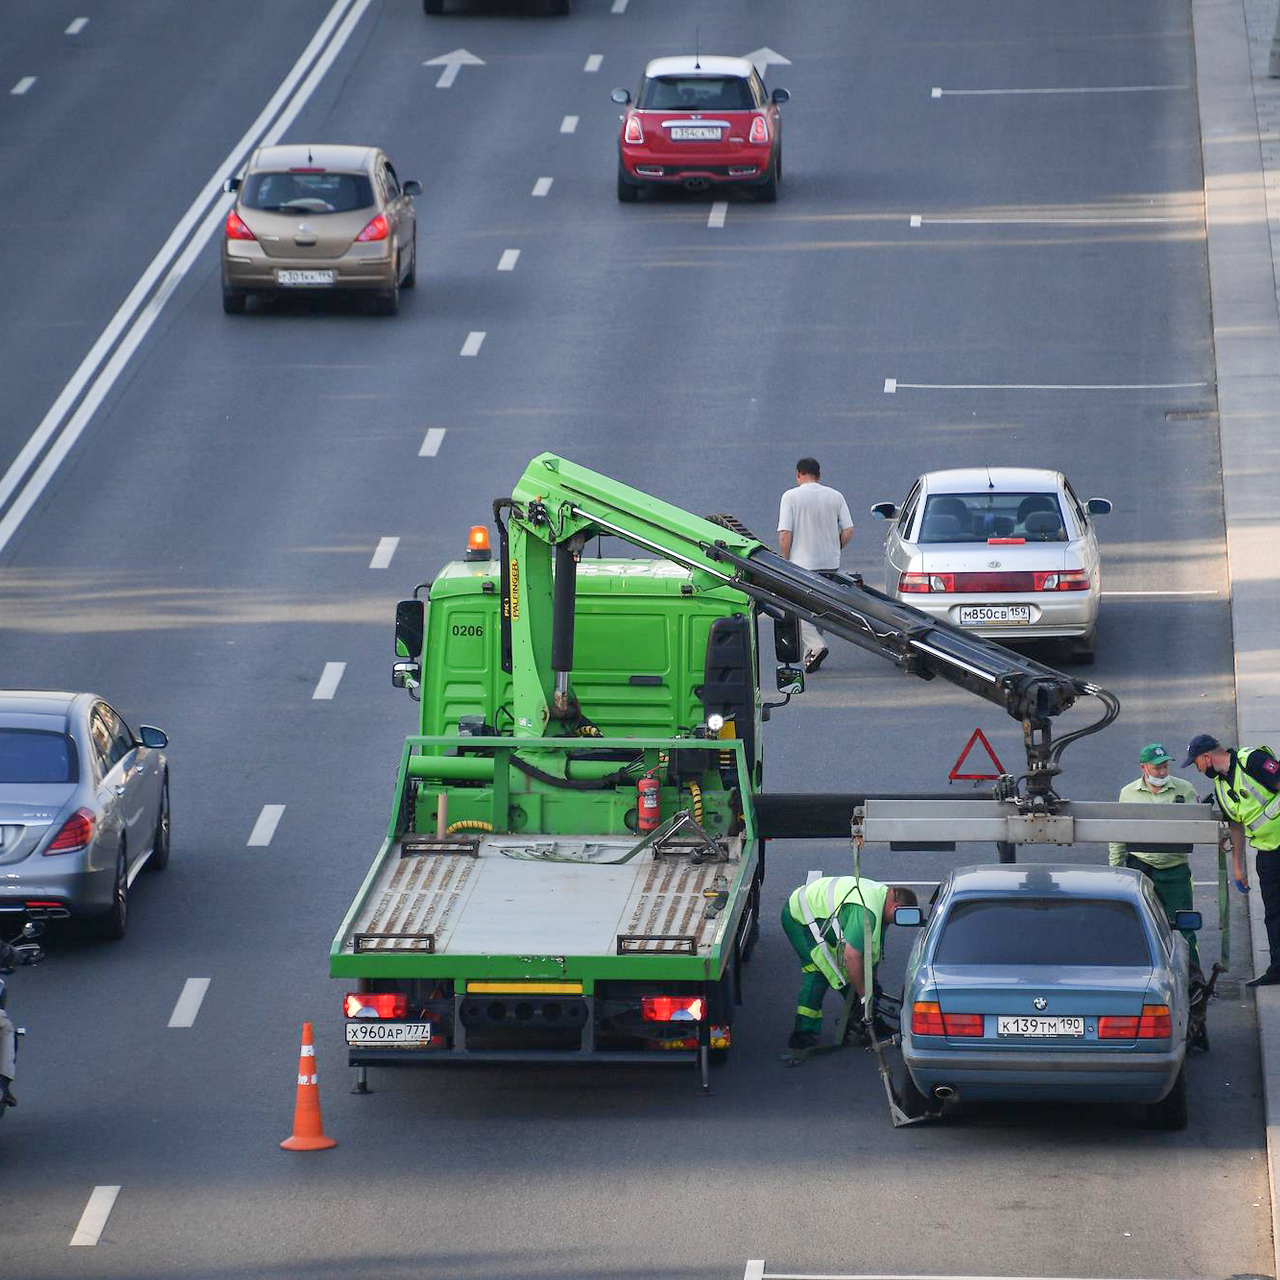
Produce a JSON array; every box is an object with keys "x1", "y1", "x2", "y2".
[{"x1": 933, "y1": 897, "x2": 1151, "y2": 965}]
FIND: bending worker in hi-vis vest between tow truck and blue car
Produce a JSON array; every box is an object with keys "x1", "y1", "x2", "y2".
[{"x1": 782, "y1": 876, "x2": 916, "y2": 1050}]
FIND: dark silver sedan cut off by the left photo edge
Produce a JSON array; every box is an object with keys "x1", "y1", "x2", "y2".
[{"x1": 0, "y1": 690, "x2": 169, "y2": 938}]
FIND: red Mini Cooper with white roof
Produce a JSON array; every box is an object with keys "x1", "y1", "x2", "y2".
[{"x1": 612, "y1": 55, "x2": 791, "y2": 201}]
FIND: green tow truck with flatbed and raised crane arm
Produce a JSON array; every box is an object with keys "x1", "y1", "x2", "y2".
[{"x1": 330, "y1": 454, "x2": 1208, "y2": 1089}]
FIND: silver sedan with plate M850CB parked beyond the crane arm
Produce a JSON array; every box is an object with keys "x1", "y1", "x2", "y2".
[{"x1": 872, "y1": 467, "x2": 1111, "y2": 663}]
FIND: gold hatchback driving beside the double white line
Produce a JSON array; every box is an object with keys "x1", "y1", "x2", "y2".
[{"x1": 223, "y1": 143, "x2": 422, "y2": 315}]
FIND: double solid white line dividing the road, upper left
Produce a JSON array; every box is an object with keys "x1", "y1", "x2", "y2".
[{"x1": 0, "y1": 0, "x2": 370, "y2": 565}]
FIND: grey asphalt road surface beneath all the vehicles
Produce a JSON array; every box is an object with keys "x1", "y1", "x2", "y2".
[{"x1": 0, "y1": 0, "x2": 1272, "y2": 1280}]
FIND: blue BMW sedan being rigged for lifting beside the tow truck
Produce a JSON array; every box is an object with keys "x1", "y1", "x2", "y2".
[{"x1": 902, "y1": 864, "x2": 1199, "y2": 1129}]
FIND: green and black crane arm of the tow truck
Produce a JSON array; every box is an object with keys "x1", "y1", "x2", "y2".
[{"x1": 494, "y1": 453, "x2": 1120, "y2": 808}]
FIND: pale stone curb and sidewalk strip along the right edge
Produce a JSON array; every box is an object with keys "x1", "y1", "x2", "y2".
[{"x1": 1190, "y1": 0, "x2": 1280, "y2": 1275}]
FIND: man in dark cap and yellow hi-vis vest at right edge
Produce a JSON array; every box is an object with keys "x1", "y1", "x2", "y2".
[{"x1": 1183, "y1": 733, "x2": 1280, "y2": 987}]
